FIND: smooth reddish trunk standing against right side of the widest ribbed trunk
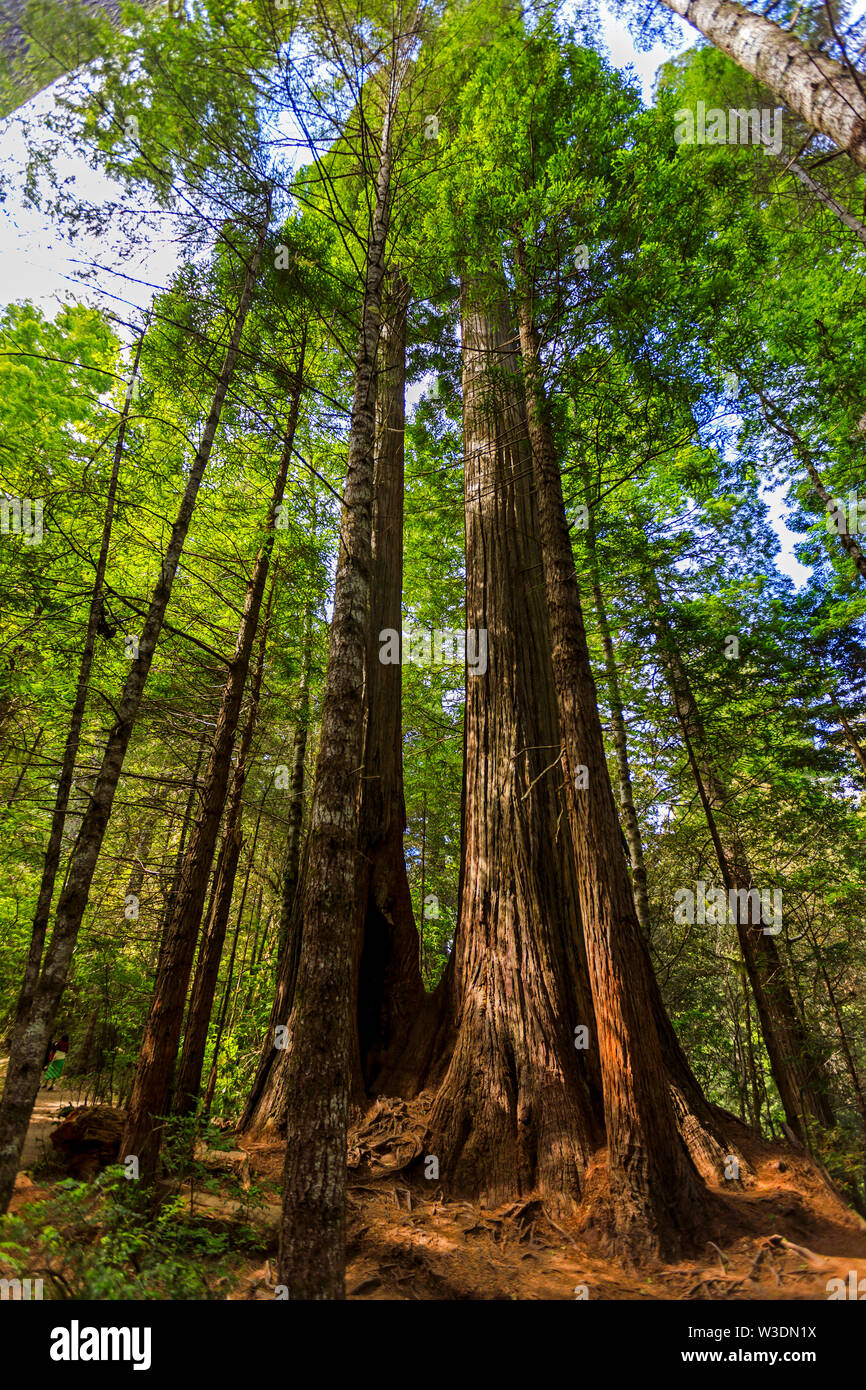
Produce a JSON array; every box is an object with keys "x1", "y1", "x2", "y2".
[{"x1": 517, "y1": 243, "x2": 705, "y2": 1258}]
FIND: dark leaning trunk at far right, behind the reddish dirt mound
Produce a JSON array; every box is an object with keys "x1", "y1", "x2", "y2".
[{"x1": 646, "y1": 571, "x2": 833, "y2": 1140}]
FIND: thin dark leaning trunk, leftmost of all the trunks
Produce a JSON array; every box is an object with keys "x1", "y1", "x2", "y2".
[{"x1": 11, "y1": 332, "x2": 145, "y2": 1051}]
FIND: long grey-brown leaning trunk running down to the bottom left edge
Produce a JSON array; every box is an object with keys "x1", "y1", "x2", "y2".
[{"x1": 0, "y1": 227, "x2": 267, "y2": 1212}]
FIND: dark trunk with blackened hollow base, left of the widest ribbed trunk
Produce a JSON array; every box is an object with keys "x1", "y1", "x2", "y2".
[{"x1": 350, "y1": 271, "x2": 424, "y2": 1098}]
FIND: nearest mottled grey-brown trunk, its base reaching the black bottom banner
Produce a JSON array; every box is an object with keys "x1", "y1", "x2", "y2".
[{"x1": 278, "y1": 108, "x2": 405, "y2": 1298}]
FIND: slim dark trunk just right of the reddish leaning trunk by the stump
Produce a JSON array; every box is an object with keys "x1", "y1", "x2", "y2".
[{"x1": 172, "y1": 585, "x2": 274, "y2": 1115}]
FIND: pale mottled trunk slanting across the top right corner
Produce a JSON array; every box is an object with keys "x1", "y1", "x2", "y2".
[{"x1": 663, "y1": 0, "x2": 866, "y2": 168}]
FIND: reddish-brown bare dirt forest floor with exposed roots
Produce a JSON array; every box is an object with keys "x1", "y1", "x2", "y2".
[{"x1": 11, "y1": 1073, "x2": 866, "y2": 1301}]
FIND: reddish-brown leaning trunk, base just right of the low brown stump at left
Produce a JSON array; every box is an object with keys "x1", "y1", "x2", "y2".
[{"x1": 121, "y1": 372, "x2": 303, "y2": 1183}]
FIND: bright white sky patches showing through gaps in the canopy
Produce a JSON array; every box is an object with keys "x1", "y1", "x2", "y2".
[{"x1": 0, "y1": 0, "x2": 811, "y2": 588}]
